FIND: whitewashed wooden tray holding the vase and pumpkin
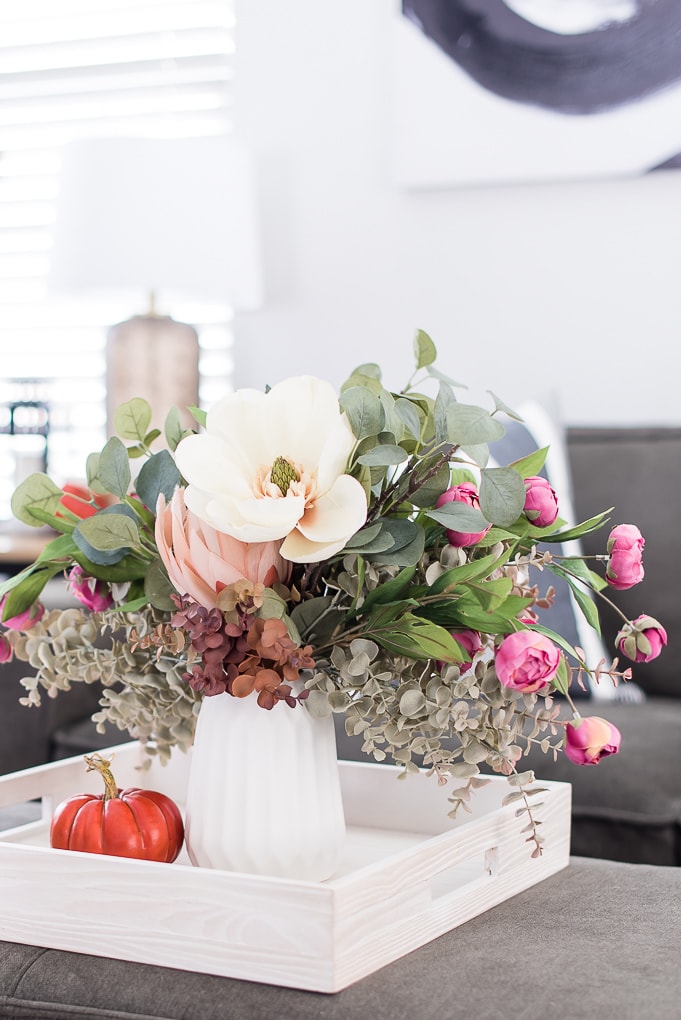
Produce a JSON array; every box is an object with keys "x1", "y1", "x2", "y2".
[{"x1": 0, "y1": 744, "x2": 571, "y2": 992}]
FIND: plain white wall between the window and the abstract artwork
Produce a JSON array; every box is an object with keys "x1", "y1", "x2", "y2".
[{"x1": 235, "y1": 0, "x2": 681, "y2": 424}]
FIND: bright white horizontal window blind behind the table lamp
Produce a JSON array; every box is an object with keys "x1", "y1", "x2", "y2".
[{"x1": 0, "y1": 0, "x2": 234, "y2": 518}]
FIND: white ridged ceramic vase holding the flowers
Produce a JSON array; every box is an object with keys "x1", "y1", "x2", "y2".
[{"x1": 186, "y1": 694, "x2": 346, "y2": 881}]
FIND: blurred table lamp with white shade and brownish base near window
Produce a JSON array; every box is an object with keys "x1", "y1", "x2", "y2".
[{"x1": 49, "y1": 137, "x2": 262, "y2": 435}]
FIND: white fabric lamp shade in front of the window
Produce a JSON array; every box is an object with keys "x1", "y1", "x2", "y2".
[{"x1": 50, "y1": 137, "x2": 262, "y2": 310}]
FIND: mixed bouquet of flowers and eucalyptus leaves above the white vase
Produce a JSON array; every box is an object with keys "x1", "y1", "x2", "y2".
[{"x1": 0, "y1": 332, "x2": 667, "y2": 853}]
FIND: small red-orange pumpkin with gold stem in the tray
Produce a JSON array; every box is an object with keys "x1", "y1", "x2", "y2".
[{"x1": 50, "y1": 754, "x2": 185, "y2": 863}]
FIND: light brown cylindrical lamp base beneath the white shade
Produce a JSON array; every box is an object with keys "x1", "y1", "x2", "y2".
[{"x1": 106, "y1": 315, "x2": 199, "y2": 436}]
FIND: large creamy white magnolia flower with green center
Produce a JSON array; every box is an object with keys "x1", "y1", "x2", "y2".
[{"x1": 175, "y1": 375, "x2": 367, "y2": 563}]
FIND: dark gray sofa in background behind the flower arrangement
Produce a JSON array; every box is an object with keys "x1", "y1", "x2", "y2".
[{"x1": 0, "y1": 428, "x2": 681, "y2": 865}]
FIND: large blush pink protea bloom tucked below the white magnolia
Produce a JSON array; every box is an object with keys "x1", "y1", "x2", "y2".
[{"x1": 156, "y1": 489, "x2": 291, "y2": 609}]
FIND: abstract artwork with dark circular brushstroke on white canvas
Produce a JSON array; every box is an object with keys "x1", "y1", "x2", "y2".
[{"x1": 394, "y1": 0, "x2": 681, "y2": 188}]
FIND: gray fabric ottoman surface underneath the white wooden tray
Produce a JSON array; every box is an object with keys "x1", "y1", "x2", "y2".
[{"x1": 0, "y1": 858, "x2": 681, "y2": 1020}]
